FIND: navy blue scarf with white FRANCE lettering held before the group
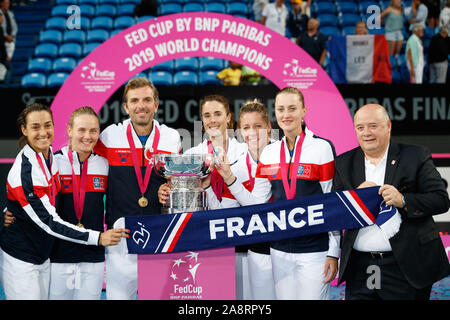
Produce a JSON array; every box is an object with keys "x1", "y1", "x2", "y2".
[{"x1": 125, "y1": 187, "x2": 401, "y2": 254}]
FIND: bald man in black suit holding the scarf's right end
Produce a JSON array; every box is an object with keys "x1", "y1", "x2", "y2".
[{"x1": 333, "y1": 104, "x2": 450, "y2": 300}]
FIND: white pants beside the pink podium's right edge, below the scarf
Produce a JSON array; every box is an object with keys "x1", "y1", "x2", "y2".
[{"x1": 247, "y1": 250, "x2": 276, "y2": 300}]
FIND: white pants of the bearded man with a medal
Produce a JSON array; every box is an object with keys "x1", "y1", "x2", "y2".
[{"x1": 105, "y1": 218, "x2": 138, "y2": 300}]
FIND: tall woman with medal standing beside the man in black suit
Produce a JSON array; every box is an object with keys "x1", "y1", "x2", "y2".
[{"x1": 248, "y1": 87, "x2": 340, "y2": 300}]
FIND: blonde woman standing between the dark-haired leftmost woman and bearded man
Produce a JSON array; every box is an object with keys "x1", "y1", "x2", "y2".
[{"x1": 49, "y1": 107, "x2": 108, "y2": 300}]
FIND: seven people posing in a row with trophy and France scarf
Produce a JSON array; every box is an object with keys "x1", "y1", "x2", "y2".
[{"x1": 0, "y1": 78, "x2": 450, "y2": 299}]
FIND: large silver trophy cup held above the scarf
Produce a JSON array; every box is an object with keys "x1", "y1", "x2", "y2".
[{"x1": 153, "y1": 154, "x2": 215, "y2": 213}]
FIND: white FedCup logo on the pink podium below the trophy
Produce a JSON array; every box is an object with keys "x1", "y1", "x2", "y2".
[{"x1": 169, "y1": 251, "x2": 203, "y2": 300}]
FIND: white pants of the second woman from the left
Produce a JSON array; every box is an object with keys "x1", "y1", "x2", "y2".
[{"x1": 49, "y1": 262, "x2": 105, "y2": 300}]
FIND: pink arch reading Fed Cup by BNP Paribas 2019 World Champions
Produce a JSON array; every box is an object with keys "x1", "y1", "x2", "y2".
[{"x1": 51, "y1": 12, "x2": 358, "y2": 154}]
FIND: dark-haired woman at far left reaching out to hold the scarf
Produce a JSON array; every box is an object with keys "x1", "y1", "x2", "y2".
[{"x1": 0, "y1": 103, "x2": 128, "y2": 300}]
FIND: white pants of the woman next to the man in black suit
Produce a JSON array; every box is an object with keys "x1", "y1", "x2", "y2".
[{"x1": 270, "y1": 248, "x2": 330, "y2": 300}]
